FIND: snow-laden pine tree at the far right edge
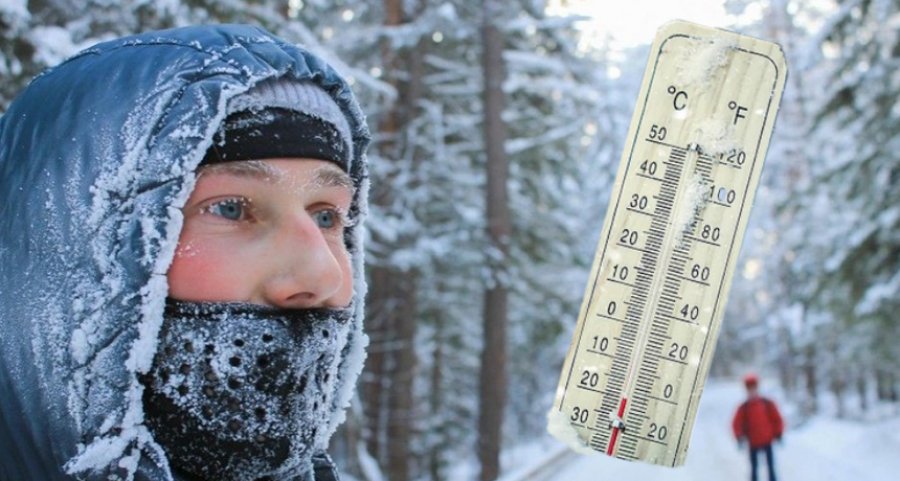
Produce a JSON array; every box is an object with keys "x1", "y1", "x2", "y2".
[{"x1": 811, "y1": 0, "x2": 900, "y2": 410}]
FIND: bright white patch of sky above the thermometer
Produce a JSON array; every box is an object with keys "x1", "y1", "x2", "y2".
[{"x1": 550, "y1": 0, "x2": 729, "y2": 48}]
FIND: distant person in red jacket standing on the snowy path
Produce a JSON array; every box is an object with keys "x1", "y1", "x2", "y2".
[{"x1": 731, "y1": 374, "x2": 784, "y2": 481}]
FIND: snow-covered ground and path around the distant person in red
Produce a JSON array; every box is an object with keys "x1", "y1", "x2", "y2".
[{"x1": 492, "y1": 381, "x2": 900, "y2": 481}]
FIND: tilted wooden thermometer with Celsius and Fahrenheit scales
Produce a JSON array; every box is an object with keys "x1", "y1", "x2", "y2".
[{"x1": 548, "y1": 21, "x2": 787, "y2": 466}]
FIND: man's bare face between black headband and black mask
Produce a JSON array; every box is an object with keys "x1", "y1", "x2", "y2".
[{"x1": 167, "y1": 159, "x2": 353, "y2": 309}]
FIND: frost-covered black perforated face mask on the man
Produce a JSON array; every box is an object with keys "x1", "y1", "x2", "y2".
[{"x1": 141, "y1": 300, "x2": 352, "y2": 481}]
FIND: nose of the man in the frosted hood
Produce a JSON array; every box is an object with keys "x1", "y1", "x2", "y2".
[{"x1": 262, "y1": 213, "x2": 350, "y2": 309}]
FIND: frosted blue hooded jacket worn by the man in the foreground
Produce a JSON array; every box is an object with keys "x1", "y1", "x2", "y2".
[{"x1": 0, "y1": 25, "x2": 369, "y2": 481}]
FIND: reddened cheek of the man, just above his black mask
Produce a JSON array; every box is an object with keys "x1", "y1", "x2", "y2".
[{"x1": 166, "y1": 236, "x2": 240, "y2": 301}]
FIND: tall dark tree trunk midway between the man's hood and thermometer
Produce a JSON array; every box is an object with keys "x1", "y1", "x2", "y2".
[{"x1": 478, "y1": 0, "x2": 511, "y2": 481}]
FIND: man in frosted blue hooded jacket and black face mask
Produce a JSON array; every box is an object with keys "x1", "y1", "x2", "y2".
[{"x1": 0, "y1": 25, "x2": 369, "y2": 481}]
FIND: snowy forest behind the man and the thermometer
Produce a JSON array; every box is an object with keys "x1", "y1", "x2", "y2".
[{"x1": 0, "y1": 0, "x2": 900, "y2": 481}]
